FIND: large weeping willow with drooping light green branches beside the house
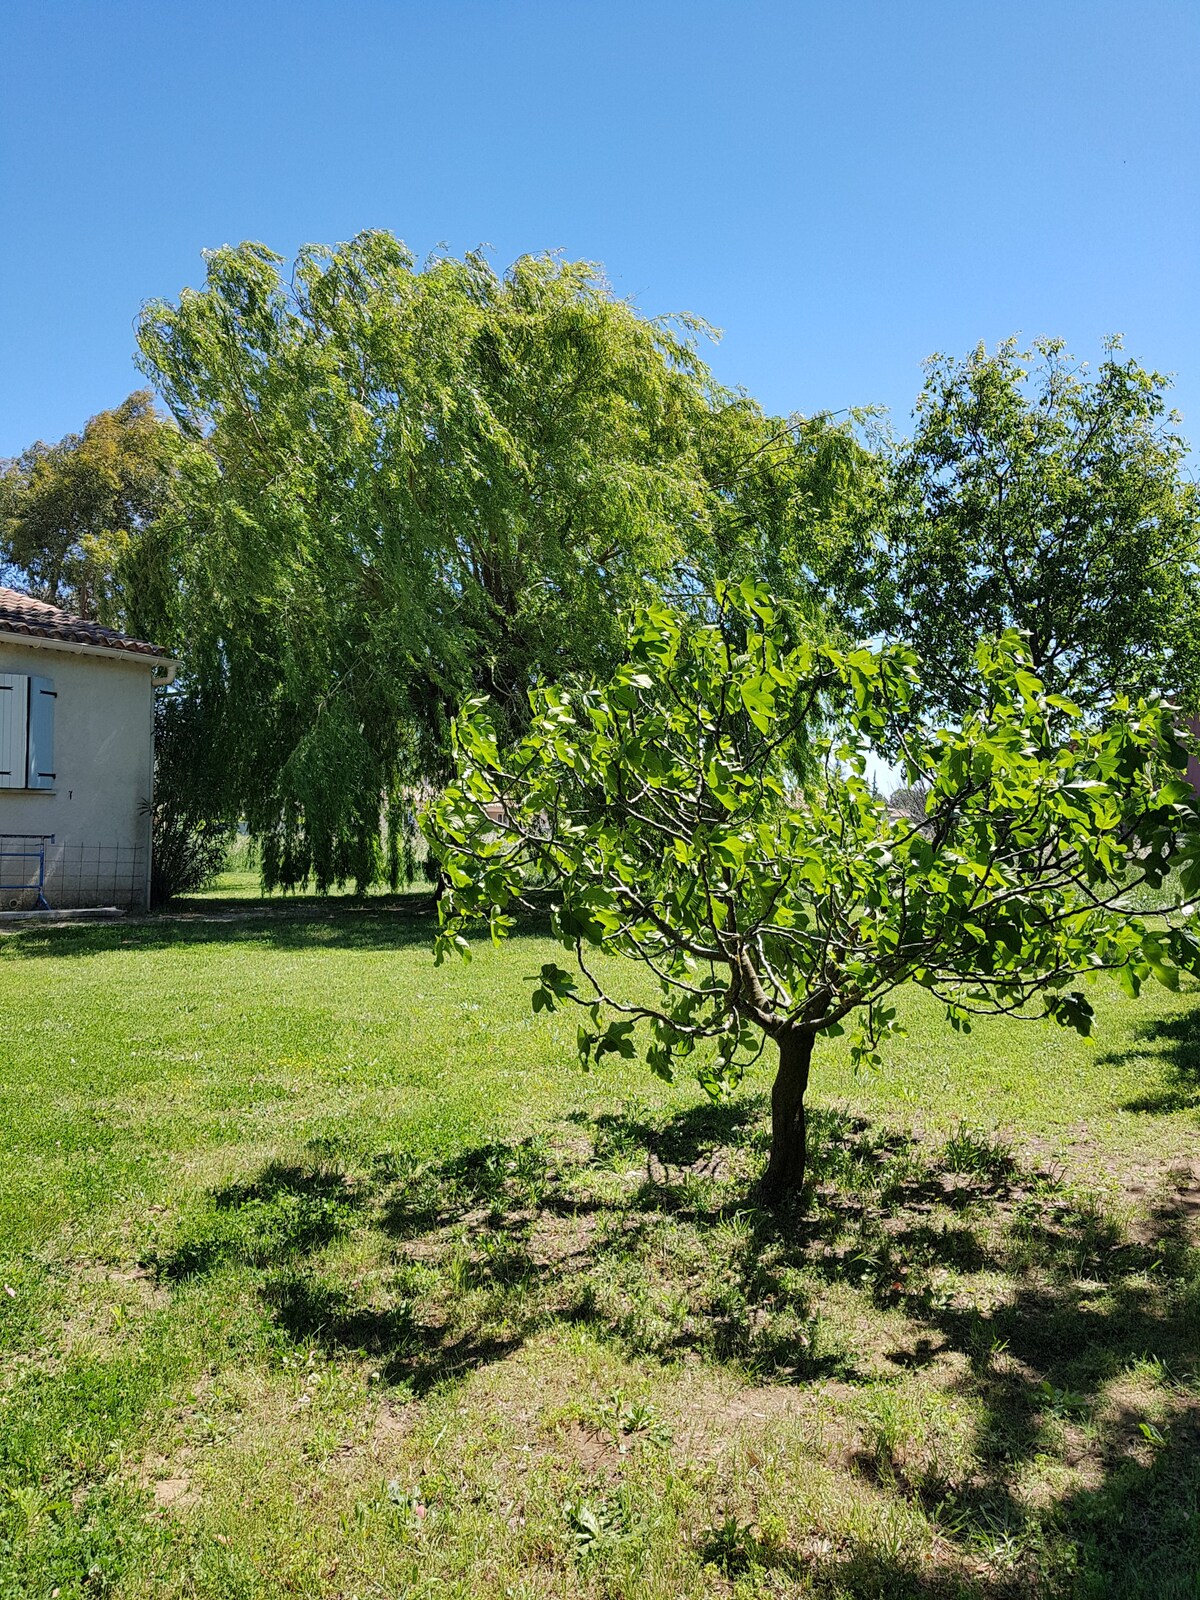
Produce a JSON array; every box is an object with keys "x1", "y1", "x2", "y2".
[{"x1": 139, "y1": 232, "x2": 864, "y2": 888}]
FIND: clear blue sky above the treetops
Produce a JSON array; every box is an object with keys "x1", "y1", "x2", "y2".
[{"x1": 0, "y1": 0, "x2": 1200, "y2": 454}]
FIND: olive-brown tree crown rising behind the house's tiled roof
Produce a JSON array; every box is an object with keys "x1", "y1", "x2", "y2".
[{"x1": 0, "y1": 390, "x2": 174, "y2": 627}]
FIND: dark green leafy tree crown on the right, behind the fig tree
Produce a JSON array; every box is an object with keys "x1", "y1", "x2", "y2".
[{"x1": 864, "y1": 339, "x2": 1200, "y2": 715}]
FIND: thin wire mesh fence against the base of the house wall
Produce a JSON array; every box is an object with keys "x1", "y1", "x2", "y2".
[{"x1": 0, "y1": 834, "x2": 149, "y2": 910}]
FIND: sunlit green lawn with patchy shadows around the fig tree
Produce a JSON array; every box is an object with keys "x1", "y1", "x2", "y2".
[{"x1": 0, "y1": 885, "x2": 1200, "y2": 1600}]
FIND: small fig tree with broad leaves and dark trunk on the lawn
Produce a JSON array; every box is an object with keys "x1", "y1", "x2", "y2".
[{"x1": 424, "y1": 582, "x2": 1200, "y2": 1197}]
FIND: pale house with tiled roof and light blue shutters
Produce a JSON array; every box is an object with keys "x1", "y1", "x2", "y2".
[{"x1": 0, "y1": 589, "x2": 176, "y2": 910}]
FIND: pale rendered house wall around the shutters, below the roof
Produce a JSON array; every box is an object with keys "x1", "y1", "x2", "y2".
[{"x1": 0, "y1": 635, "x2": 154, "y2": 910}]
